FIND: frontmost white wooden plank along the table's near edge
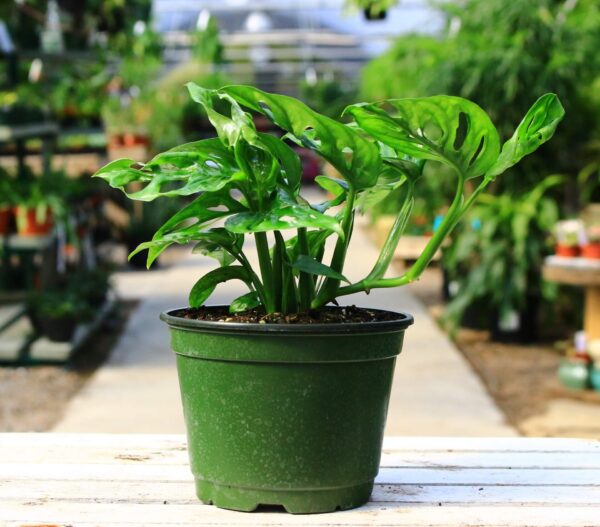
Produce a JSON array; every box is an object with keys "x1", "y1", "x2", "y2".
[{"x1": 0, "y1": 502, "x2": 600, "y2": 527}]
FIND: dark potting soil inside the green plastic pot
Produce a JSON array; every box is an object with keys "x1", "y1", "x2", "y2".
[{"x1": 174, "y1": 306, "x2": 401, "y2": 324}]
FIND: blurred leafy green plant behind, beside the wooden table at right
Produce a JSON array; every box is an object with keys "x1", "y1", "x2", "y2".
[{"x1": 443, "y1": 176, "x2": 562, "y2": 327}]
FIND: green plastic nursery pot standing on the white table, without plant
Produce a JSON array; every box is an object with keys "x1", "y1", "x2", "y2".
[{"x1": 161, "y1": 310, "x2": 413, "y2": 513}]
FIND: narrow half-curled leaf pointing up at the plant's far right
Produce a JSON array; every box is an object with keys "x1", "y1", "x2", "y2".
[{"x1": 486, "y1": 93, "x2": 565, "y2": 179}]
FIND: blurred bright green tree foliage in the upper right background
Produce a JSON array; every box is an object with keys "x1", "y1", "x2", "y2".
[{"x1": 361, "y1": 0, "x2": 600, "y2": 199}]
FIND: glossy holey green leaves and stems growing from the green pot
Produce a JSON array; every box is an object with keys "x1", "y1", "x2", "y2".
[{"x1": 96, "y1": 84, "x2": 564, "y2": 313}]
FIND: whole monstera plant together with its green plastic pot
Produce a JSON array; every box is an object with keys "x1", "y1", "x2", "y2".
[{"x1": 96, "y1": 84, "x2": 564, "y2": 513}]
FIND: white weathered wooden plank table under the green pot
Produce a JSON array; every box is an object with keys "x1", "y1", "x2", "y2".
[{"x1": 0, "y1": 434, "x2": 600, "y2": 527}]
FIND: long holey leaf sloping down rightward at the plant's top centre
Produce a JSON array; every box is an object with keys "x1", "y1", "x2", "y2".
[{"x1": 219, "y1": 86, "x2": 381, "y2": 190}]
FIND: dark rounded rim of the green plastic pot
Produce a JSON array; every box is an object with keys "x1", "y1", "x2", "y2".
[{"x1": 160, "y1": 304, "x2": 414, "y2": 336}]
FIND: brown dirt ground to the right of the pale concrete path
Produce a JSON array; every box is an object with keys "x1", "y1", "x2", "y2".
[{"x1": 410, "y1": 268, "x2": 600, "y2": 437}]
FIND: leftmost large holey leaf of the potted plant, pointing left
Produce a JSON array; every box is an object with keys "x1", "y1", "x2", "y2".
[{"x1": 95, "y1": 139, "x2": 242, "y2": 201}]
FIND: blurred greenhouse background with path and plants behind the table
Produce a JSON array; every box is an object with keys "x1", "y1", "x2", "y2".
[{"x1": 0, "y1": 0, "x2": 600, "y2": 439}]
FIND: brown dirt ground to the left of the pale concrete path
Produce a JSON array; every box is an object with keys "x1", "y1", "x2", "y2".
[{"x1": 0, "y1": 301, "x2": 137, "y2": 432}]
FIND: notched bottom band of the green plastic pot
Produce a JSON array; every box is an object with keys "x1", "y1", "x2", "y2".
[{"x1": 196, "y1": 479, "x2": 373, "y2": 514}]
